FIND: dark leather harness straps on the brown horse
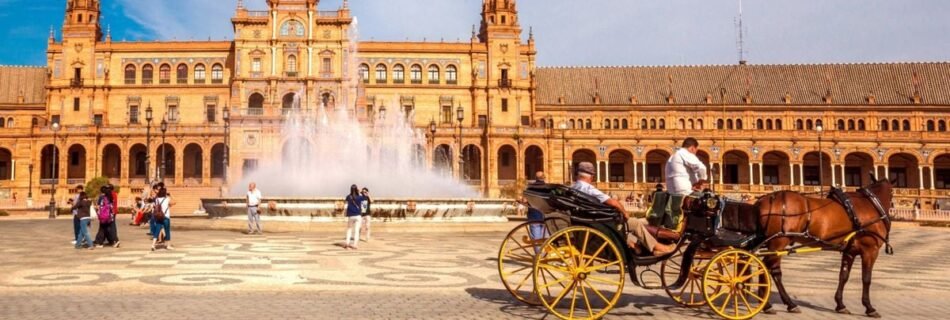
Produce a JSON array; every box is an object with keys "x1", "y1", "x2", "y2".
[{"x1": 762, "y1": 188, "x2": 894, "y2": 255}]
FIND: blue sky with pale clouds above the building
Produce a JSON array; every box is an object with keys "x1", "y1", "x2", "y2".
[{"x1": 0, "y1": 0, "x2": 950, "y2": 66}]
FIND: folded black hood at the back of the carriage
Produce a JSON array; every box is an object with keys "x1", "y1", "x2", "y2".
[{"x1": 524, "y1": 184, "x2": 620, "y2": 222}]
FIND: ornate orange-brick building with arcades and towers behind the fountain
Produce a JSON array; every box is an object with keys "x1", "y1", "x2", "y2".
[{"x1": 0, "y1": 0, "x2": 950, "y2": 209}]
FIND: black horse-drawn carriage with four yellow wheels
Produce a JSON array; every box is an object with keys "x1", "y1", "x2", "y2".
[{"x1": 498, "y1": 180, "x2": 890, "y2": 319}]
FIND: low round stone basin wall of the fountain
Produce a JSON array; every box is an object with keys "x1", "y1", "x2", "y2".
[{"x1": 201, "y1": 198, "x2": 517, "y2": 222}]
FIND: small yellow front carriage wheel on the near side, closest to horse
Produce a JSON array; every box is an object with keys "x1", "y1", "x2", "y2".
[{"x1": 703, "y1": 249, "x2": 772, "y2": 320}]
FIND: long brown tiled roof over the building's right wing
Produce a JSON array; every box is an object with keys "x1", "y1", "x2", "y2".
[{"x1": 537, "y1": 62, "x2": 950, "y2": 106}]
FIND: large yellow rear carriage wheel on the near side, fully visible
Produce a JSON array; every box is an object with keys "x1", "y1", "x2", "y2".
[{"x1": 534, "y1": 227, "x2": 626, "y2": 319}]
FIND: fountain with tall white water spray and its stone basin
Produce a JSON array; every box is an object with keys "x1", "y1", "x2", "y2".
[{"x1": 203, "y1": 19, "x2": 513, "y2": 221}]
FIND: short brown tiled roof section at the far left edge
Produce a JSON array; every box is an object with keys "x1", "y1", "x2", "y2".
[{"x1": 0, "y1": 66, "x2": 46, "y2": 105}]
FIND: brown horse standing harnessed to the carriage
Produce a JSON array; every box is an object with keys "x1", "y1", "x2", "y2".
[{"x1": 755, "y1": 176, "x2": 892, "y2": 318}]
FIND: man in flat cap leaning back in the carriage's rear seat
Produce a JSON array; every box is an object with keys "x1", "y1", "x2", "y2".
[{"x1": 571, "y1": 162, "x2": 676, "y2": 256}]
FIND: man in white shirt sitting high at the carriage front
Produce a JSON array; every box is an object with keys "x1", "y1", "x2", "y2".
[{"x1": 666, "y1": 138, "x2": 708, "y2": 228}]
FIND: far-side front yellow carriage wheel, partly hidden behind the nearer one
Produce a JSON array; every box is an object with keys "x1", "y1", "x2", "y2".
[{"x1": 660, "y1": 246, "x2": 711, "y2": 308}]
